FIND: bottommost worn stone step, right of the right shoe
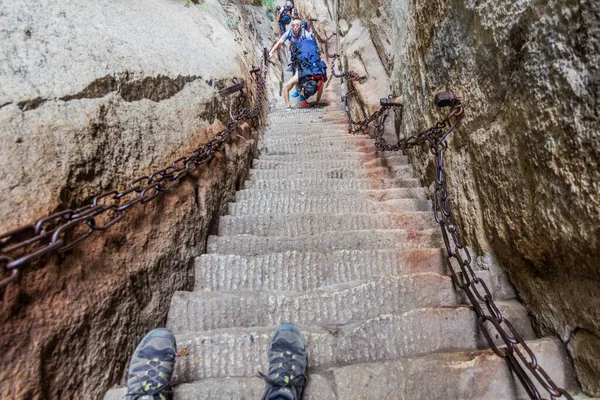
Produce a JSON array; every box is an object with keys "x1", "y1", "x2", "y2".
[{"x1": 331, "y1": 338, "x2": 577, "y2": 400}]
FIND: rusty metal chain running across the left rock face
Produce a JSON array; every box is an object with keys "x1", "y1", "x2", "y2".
[{"x1": 0, "y1": 49, "x2": 268, "y2": 288}]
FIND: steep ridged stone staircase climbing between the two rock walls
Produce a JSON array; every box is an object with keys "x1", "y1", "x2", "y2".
[{"x1": 105, "y1": 76, "x2": 576, "y2": 399}]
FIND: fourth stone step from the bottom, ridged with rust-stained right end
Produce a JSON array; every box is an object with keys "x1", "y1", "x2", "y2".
[{"x1": 194, "y1": 249, "x2": 445, "y2": 292}]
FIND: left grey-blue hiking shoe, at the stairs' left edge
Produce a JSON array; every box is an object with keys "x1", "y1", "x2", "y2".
[{"x1": 125, "y1": 328, "x2": 176, "y2": 400}]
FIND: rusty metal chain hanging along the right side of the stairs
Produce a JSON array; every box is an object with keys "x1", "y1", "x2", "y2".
[{"x1": 366, "y1": 92, "x2": 572, "y2": 400}]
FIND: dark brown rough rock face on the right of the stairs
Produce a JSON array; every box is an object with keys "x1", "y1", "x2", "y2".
[{"x1": 302, "y1": 0, "x2": 600, "y2": 395}]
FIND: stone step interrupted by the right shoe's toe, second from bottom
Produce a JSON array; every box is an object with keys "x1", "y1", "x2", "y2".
[{"x1": 174, "y1": 302, "x2": 535, "y2": 383}]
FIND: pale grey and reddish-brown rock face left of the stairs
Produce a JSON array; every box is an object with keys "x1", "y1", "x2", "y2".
[{"x1": 0, "y1": 0, "x2": 280, "y2": 398}]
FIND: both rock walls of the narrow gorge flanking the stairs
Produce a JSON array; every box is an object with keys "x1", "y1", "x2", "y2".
[{"x1": 0, "y1": 0, "x2": 600, "y2": 399}]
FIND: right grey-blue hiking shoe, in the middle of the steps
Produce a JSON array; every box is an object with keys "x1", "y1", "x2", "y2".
[{"x1": 260, "y1": 323, "x2": 308, "y2": 400}]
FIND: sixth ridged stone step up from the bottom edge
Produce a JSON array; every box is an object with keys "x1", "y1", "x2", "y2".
[{"x1": 219, "y1": 211, "x2": 437, "y2": 237}]
